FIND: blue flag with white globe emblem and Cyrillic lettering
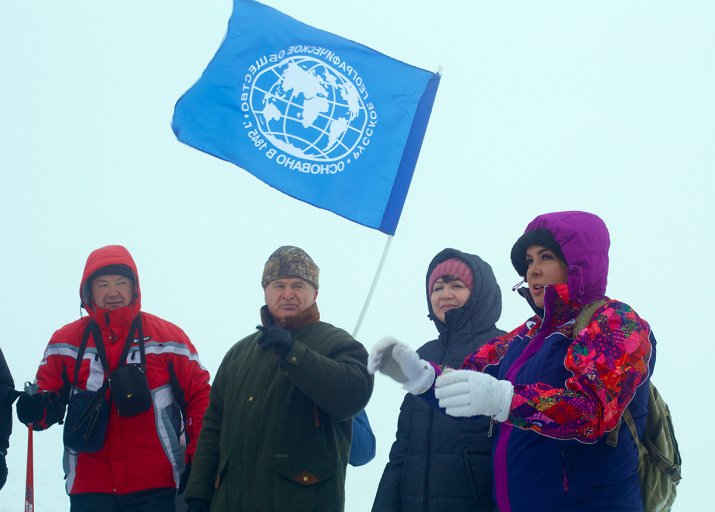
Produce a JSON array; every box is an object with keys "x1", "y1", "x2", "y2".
[{"x1": 172, "y1": 0, "x2": 440, "y2": 235}]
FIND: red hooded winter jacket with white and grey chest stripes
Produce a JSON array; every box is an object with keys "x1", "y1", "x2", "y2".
[{"x1": 37, "y1": 245, "x2": 209, "y2": 494}]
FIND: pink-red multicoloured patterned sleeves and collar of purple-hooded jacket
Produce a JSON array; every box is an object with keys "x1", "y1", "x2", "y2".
[{"x1": 462, "y1": 285, "x2": 652, "y2": 443}]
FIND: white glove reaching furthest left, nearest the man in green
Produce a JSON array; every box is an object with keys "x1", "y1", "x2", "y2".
[{"x1": 367, "y1": 337, "x2": 434, "y2": 395}]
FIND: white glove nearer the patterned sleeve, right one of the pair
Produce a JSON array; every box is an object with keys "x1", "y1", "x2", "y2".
[{"x1": 434, "y1": 370, "x2": 514, "y2": 421}]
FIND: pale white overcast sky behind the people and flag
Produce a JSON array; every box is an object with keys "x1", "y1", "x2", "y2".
[{"x1": 0, "y1": 0, "x2": 715, "y2": 512}]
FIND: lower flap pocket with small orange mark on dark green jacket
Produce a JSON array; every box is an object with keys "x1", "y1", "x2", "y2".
[{"x1": 267, "y1": 454, "x2": 343, "y2": 511}]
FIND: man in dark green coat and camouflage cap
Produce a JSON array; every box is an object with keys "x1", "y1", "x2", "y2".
[{"x1": 184, "y1": 246, "x2": 373, "y2": 512}]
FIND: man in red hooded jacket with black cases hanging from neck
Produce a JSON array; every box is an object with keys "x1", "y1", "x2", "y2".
[{"x1": 17, "y1": 245, "x2": 209, "y2": 512}]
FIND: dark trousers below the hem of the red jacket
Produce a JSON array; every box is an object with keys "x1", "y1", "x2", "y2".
[{"x1": 70, "y1": 488, "x2": 176, "y2": 512}]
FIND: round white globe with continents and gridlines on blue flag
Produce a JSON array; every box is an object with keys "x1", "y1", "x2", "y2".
[{"x1": 249, "y1": 56, "x2": 368, "y2": 162}]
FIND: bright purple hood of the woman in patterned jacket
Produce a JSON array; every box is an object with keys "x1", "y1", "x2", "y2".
[{"x1": 524, "y1": 211, "x2": 611, "y2": 304}]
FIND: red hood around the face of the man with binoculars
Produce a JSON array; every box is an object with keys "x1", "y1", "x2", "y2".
[{"x1": 79, "y1": 245, "x2": 141, "y2": 324}]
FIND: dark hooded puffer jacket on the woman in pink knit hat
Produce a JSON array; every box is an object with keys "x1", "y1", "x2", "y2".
[{"x1": 372, "y1": 249, "x2": 505, "y2": 512}]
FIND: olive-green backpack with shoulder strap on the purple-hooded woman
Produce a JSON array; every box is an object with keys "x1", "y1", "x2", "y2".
[{"x1": 574, "y1": 300, "x2": 682, "y2": 512}]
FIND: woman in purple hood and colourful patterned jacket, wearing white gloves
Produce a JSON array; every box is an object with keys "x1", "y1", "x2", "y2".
[{"x1": 368, "y1": 212, "x2": 655, "y2": 512}]
